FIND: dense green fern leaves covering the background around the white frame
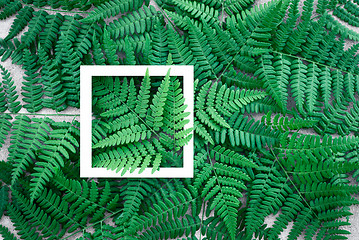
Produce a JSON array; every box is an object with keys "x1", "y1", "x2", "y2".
[{"x1": 0, "y1": 0, "x2": 359, "y2": 239}]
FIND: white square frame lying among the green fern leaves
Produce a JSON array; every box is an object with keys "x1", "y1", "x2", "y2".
[{"x1": 80, "y1": 65, "x2": 194, "y2": 178}]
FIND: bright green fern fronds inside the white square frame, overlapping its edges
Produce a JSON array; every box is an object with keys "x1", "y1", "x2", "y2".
[{"x1": 93, "y1": 67, "x2": 191, "y2": 175}]
